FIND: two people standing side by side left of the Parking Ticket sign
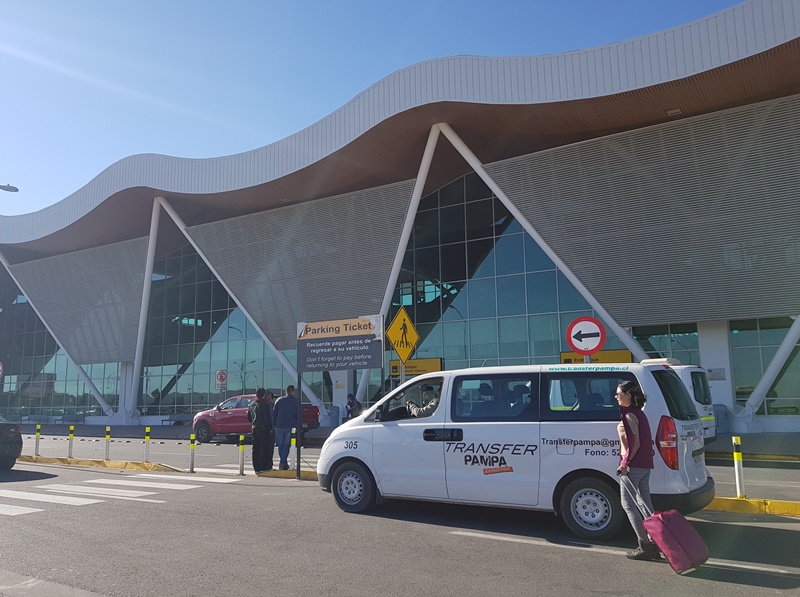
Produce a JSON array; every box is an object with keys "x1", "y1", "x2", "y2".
[{"x1": 247, "y1": 386, "x2": 300, "y2": 474}]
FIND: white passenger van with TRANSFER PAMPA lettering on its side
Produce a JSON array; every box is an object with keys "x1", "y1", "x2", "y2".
[{"x1": 317, "y1": 363, "x2": 714, "y2": 539}]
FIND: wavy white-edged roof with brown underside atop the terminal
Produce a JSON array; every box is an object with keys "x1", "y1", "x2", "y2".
[{"x1": 0, "y1": 0, "x2": 800, "y2": 260}]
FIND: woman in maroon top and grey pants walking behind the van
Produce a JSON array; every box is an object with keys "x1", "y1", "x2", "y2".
[{"x1": 616, "y1": 381, "x2": 661, "y2": 560}]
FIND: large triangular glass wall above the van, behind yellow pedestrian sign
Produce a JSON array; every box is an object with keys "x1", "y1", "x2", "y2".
[{"x1": 369, "y1": 173, "x2": 625, "y2": 400}]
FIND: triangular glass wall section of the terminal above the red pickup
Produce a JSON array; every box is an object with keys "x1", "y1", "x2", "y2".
[{"x1": 138, "y1": 244, "x2": 332, "y2": 415}]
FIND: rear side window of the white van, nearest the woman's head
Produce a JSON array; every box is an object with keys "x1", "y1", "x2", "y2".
[{"x1": 541, "y1": 371, "x2": 636, "y2": 421}]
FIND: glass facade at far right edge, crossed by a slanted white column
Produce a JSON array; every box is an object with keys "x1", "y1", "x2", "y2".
[{"x1": 728, "y1": 317, "x2": 800, "y2": 415}]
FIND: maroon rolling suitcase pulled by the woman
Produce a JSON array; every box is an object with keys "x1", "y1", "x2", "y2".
[{"x1": 620, "y1": 476, "x2": 708, "y2": 574}]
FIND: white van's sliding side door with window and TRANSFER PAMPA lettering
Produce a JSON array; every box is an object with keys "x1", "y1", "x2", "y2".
[{"x1": 444, "y1": 372, "x2": 539, "y2": 506}]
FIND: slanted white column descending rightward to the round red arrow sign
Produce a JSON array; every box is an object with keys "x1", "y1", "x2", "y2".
[{"x1": 438, "y1": 123, "x2": 647, "y2": 361}]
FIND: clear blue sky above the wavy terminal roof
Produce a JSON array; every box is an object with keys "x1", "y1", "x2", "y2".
[{"x1": 0, "y1": 0, "x2": 738, "y2": 215}]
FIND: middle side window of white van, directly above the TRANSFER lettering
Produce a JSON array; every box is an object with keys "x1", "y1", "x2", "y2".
[{"x1": 450, "y1": 375, "x2": 539, "y2": 421}]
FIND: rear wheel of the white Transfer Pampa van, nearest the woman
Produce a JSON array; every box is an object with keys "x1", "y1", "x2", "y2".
[{"x1": 560, "y1": 477, "x2": 625, "y2": 539}]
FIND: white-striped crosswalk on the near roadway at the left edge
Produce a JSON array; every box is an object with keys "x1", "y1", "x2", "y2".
[{"x1": 0, "y1": 474, "x2": 240, "y2": 516}]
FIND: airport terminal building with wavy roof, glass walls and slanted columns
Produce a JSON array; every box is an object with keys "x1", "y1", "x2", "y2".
[{"x1": 0, "y1": 0, "x2": 800, "y2": 432}]
